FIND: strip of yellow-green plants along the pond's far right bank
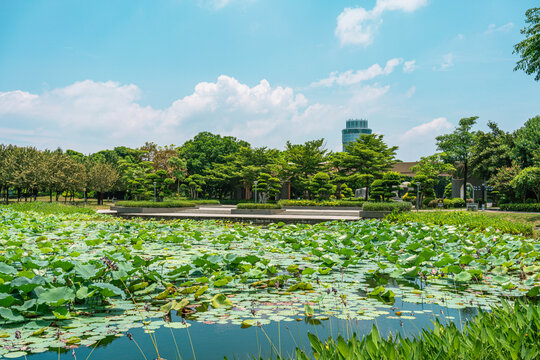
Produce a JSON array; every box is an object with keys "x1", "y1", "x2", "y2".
[{"x1": 386, "y1": 210, "x2": 533, "y2": 236}]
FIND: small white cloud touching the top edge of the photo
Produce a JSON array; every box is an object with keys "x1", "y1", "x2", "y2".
[{"x1": 334, "y1": 0, "x2": 427, "y2": 46}]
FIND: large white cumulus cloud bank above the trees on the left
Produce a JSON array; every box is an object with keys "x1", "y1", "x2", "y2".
[{"x1": 0, "y1": 75, "x2": 339, "y2": 151}]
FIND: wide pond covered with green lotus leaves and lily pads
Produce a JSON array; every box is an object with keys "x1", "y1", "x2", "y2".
[{"x1": 0, "y1": 208, "x2": 540, "y2": 360}]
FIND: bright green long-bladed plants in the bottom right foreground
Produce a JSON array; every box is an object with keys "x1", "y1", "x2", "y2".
[{"x1": 296, "y1": 302, "x2": 540, "y2": 360}]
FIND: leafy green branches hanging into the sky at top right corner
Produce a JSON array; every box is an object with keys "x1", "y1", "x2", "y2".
[{"x1": 514, "y1": 8, "x2": 540, "y2": 81}]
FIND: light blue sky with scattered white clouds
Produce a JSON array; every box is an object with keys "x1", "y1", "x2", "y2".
[{"x1": 0, "y1": 0, "x2": 540, "y2": 161}]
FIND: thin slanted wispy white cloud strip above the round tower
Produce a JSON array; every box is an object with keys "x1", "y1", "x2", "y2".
[{"x1": 311, "y1": 58, "x2": 403, "y2": 87}]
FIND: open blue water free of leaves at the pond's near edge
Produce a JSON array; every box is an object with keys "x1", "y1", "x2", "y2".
[{"x1": 23, "y1": 299, "x2": 477, "y2": 360}]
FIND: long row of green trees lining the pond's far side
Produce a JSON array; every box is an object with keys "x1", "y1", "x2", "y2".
[{"x1": 0, "y1": 116, "x2": 540, "y2": 203}]
